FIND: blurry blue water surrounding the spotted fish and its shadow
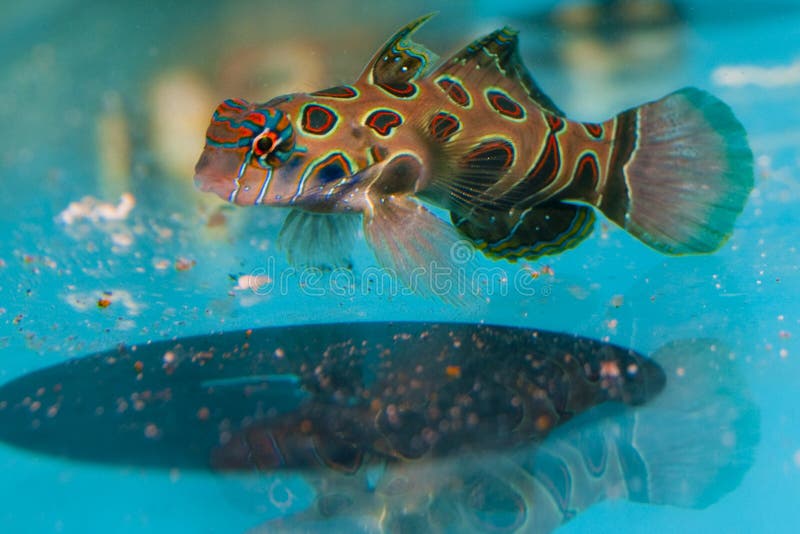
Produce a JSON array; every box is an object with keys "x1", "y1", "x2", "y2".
[{"x1": 0, "y1": 0, "x2": 800, "y2": 533}]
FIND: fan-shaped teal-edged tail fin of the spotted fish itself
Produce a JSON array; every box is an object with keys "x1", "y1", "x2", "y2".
[{"x1": 599, "y1": 87, "x2": 753, "y2": 254}]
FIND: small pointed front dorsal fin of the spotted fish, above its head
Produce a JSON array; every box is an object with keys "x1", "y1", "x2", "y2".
[{"x1": 358, "y1": 13, "x2": 439, "y2": 86}]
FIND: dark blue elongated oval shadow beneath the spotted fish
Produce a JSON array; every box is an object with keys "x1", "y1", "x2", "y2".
[{"x1": 0, "y1": 323, "x2": 664, "y2": 471}]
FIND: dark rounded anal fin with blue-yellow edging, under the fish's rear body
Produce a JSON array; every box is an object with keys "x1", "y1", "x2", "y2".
[{"x1": 451, "y1": 202, "x2": 595, "y2": 261}]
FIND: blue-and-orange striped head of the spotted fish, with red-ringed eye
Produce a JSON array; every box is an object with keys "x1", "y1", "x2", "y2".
[{"x1": 194, "y1": 94, "x2": 367, "y2": 211}]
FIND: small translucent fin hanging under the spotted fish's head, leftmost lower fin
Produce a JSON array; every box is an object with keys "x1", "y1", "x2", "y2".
[{"x1": 278, "y1": 209, "x2": 360, "y2": 270}]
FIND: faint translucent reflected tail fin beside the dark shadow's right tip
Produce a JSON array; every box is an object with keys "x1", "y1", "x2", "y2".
[{"x1": 620, "y1": 340, "x2": 760, "y2": 508}]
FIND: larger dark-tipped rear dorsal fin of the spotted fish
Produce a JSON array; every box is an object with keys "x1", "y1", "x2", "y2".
[{"x1": 432, "y1": 26, "x2": 564, "y2": 117}]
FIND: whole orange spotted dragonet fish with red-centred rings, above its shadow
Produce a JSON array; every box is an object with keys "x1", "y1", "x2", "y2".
[{"x1": 194, "y1": 15, "x2": 753, "y2": 293}]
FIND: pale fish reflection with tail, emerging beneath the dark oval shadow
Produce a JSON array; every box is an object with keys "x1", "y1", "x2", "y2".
[{"x1": 242, "y1": 339, "x2": 760, "y2": 533}]
